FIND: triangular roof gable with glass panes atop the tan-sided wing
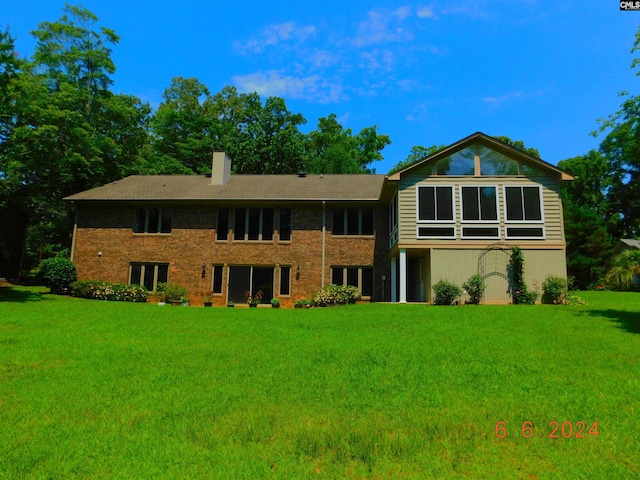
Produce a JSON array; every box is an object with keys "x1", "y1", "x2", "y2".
[{"x1": 389, "y1": 132, "x2": 574, "y2": 181}]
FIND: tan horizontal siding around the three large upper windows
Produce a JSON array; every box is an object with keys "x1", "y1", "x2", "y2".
[{"x1": 398, "y1": 175, "x2": 565, "y2": 248}]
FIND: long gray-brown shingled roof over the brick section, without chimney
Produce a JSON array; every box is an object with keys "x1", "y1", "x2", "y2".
[{"x1": 65, "y1": 175, "x2": 385, "y2": 202}]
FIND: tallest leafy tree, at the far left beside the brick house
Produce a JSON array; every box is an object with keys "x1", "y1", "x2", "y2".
[{"x1": 0, "y1": 5, "x2": 150, "y2": 266}]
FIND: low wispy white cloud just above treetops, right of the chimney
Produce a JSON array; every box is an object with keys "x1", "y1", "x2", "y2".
[{"x1": 232, "y1": 70, "x2": 344, "y2": 103}]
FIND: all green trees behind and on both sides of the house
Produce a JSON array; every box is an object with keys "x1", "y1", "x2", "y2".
[{"x1": 0, "y1": 5, "x2": 640, "y2": 288}]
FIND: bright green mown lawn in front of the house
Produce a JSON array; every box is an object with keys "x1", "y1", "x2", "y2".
[{"x1": 0, "y1": 287, "x2": 640, "y2": 479}]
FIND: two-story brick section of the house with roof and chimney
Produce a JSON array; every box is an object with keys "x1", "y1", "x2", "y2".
[{"x1": 67, "y1": 153, "x2": 392, "y2": 306}]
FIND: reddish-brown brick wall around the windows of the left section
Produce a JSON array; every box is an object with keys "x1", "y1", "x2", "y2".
[{"x1": 74, "y1": 204, "x2": 390, "y2": 307}]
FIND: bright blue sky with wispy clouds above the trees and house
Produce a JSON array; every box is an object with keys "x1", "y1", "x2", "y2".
[{"x1": 0, "y1": 0, "x2": 640, "y2": 173}]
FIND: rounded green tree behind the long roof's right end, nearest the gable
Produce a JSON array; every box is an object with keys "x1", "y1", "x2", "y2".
[{"x1": 305, "y1": 113, "x2": 391, "y2": 174}]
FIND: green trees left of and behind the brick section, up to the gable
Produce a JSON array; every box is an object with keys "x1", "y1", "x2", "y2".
[{"x1": 0, "y1": 4, "x2": 391, "y2": 269}]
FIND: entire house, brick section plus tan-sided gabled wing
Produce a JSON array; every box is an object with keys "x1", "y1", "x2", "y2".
[{"x1": 66, "y1": 133, "x2": 572, "y2": 306}]
